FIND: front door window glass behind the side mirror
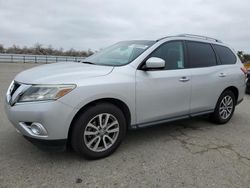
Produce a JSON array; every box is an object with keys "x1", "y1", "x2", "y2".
[{"x1": 150, "y1": 41, "x2": 184, "y2": 70}]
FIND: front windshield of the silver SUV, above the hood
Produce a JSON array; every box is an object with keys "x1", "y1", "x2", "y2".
[{"x1": 83, "y1": 40, "x2": 155, "y2": 66}]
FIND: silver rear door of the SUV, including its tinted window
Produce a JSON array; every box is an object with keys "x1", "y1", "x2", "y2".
[{"x1": 186, "y1": 41, "x2": 227, "y2": 113}]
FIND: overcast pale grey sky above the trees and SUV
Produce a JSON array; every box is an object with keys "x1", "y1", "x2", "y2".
[{"x1": 0, "y1": 0, "x2": 250, "y2": 53}]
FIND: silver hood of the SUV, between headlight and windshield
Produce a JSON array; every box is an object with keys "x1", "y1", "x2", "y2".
[{"x1": 15, "y1": 62, "x2": 113, "y2": 84}]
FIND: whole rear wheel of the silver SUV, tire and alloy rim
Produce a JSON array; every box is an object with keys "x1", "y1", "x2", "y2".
[{"x1": 210, "y1": 90, "x2": 236, "y2": 124}]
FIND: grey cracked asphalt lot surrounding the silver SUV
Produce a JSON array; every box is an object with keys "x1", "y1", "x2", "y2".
[{"x1": 0, "y1": 63, "x2": 250, "y2": 188}]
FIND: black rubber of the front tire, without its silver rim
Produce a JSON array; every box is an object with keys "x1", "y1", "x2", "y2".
[{"x1": 71, "y1": 103, "x2": 127, "y2": 159}]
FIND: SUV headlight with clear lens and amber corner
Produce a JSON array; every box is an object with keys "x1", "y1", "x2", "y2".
[{"x1": 18, "y1": 85, "x2": 76, "y2": 102}]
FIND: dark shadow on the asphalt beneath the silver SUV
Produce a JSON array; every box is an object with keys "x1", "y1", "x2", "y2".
[{"x1": 15, "y1": 116, "x2": 219, "y2": 162}]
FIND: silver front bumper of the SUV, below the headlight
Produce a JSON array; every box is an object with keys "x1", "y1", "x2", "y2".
[{"x1": 5, "y1": 100, "x2": 74, "y2": 141}]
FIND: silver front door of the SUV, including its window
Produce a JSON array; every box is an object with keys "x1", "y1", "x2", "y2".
[{"x1": 136, "y1": 41, "x2": 192, "y2": 124}]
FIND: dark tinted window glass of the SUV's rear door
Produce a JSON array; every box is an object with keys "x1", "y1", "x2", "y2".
[{"x1": 187, "y1": 41, "x2": 217, "y2": 68}]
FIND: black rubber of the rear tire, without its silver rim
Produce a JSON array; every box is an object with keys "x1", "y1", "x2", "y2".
[{"x1": 210, "y1": 90, "x2": 236, "y2": 124}]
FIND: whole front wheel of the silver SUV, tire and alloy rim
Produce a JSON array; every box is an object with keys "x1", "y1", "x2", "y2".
[{"x1": 71, "y1": 103, "x2": 127, "y2": 159}]
